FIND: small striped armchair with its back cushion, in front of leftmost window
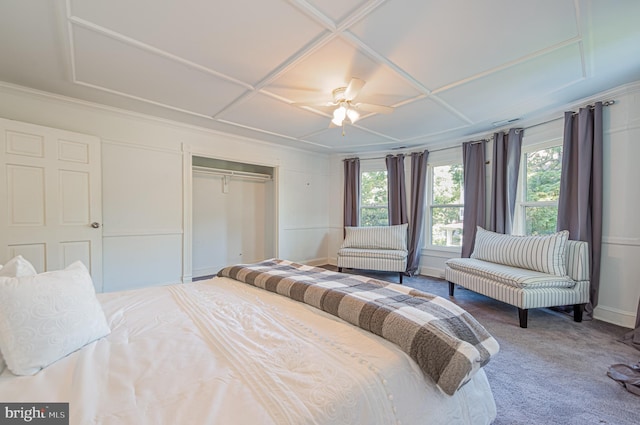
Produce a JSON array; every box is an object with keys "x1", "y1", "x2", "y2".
[{"x1": 338, "y1": 224, "x2": 409, "y2": 283}]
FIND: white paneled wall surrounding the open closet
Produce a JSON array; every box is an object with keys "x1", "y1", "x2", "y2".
[{"x1": 0, "y1": 83, "x2": 329, "y2": 291}]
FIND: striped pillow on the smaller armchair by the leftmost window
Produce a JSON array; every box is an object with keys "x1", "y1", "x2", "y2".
[{"x1": 340, "y1": 223, "x2": 409, "y2": 250}]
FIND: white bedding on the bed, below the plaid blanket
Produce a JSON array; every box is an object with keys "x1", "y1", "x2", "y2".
[{"x1": 0, "y1": 278, "x2": 496, "y2": 425}]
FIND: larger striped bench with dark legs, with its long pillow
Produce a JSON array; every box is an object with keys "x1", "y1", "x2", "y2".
[{"x1": 445, "y1": 227, "x2": 590, "y2": 328}]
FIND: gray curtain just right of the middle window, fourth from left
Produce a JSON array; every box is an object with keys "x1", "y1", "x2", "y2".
[{"x1": 461, "y1": 140, "x2": 487, "y2": 258}]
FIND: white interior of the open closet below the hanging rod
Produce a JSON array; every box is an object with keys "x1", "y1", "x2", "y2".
[{"x1": 192, "y1": 170, "x2": 273, "y2": 277}]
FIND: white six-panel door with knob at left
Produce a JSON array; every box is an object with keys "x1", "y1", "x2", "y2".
[{"x1": 0, "y1": 118, "x2": 102, "y2": 291}]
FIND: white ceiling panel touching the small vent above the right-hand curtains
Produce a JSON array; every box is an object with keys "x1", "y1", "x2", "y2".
[{"x1": 438, "y1": 44, "x2": 583, "y2": 122}]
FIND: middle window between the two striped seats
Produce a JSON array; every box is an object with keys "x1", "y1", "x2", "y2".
[{"x1": 429, "y1": 164, "x2": 464, "y2": 247}]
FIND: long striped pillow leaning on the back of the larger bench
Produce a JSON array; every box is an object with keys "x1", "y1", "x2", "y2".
[{"x1": 471, "y1": 226, "x2": 569, "y2": 276}]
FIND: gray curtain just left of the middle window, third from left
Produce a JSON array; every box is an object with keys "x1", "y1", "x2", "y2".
[{"x1": 407, "y1": 151, "x2": 429, "y2": 276}]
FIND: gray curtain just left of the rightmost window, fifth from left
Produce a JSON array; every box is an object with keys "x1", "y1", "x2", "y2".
[{"x1": 488, "y1": 128, "x2": 524, "y2": 235}]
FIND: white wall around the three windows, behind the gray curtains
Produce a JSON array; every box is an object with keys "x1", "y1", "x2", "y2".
[{"x1": 329, "y1": 82, "x2": 640, "y2": 328}]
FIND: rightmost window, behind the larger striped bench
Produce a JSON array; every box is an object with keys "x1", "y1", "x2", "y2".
[{"x1": 516, "y1": 146, "x2": 562, "y2": 235}]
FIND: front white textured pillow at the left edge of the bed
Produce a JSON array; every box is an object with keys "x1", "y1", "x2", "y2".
[{"x1": 0, "y1": 261, "x2": 110, "y2": 375}]
